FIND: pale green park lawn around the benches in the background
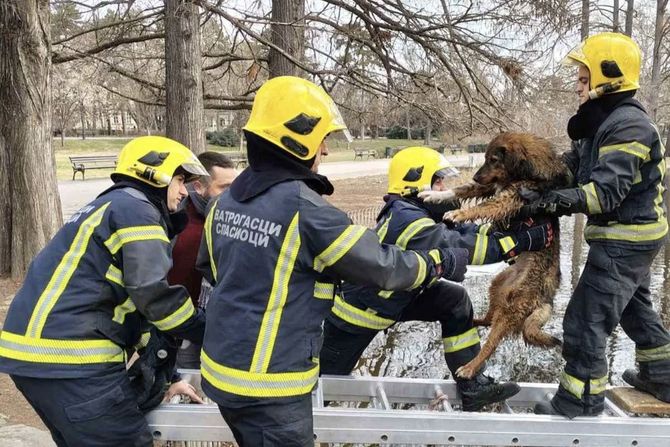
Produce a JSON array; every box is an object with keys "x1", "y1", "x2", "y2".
[{"x1": 52, "y1": 138, "x2": 438, "y2": 180}]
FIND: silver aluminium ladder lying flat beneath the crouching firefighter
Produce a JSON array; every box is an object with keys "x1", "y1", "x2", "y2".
[{"x1": 147, "y1": 370, "x2": 670, "y2": 447}]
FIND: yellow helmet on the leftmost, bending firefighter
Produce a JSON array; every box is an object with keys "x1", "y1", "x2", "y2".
[{"x1": 112, "y1": 137, "x2": 209, "y2": 188}]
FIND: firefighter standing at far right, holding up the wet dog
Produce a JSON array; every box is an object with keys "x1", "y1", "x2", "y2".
[{"x1": 522, "y1": 33, "x2": 670, "y2": 418}]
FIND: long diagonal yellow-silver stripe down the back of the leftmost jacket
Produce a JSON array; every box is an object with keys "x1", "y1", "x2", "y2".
[{"x1": 26, "y1": 203, "x2": 109, "y2": 338}]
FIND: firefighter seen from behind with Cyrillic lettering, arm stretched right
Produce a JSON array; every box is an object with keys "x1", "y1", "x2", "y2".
[{"x1": 201, "y1": 76, "x2": 467, "y2": 447}]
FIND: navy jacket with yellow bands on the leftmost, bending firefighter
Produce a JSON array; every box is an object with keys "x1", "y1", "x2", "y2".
[{"x1": 0, "y1": 188, "x2": 204, "y2": 378}]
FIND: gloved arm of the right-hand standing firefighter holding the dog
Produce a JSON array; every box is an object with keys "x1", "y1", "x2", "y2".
[{"x1": 519, "y1": 122, "x2": 650, "y2": 217}]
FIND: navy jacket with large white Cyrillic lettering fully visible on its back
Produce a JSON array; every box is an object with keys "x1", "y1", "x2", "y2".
[{"x1": 199, "y1": 181, "x2": 433, "y2": 405}]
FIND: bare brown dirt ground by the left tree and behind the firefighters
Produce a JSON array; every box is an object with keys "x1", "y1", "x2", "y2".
[{"x1": 0, "y1": 175, "x2": 472, "y2": 430}]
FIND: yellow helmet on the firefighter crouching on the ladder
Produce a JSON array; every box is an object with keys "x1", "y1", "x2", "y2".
[{"x1": 388, "y1": 146, "x2": 458, "y2": 194}]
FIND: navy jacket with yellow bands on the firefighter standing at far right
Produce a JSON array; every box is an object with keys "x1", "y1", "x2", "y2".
[{"x1": 560, "y1": 99, "x2": 668, "y2": 246}]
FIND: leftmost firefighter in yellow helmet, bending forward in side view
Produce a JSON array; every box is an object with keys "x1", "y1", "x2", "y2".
[{"x1": 0, "y1": 137, "x2": 207, "y2": 447}]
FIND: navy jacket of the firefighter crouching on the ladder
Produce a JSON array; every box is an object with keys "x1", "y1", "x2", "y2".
[{"x1": 328, "y1": 199, "x2": 504, "y2": 332}]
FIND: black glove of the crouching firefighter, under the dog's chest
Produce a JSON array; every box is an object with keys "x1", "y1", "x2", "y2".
[{"x1": 494, "y1": 218, "x2": 554, "y2": 260}]
